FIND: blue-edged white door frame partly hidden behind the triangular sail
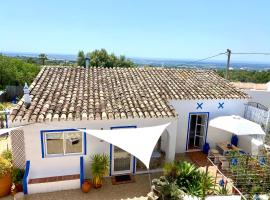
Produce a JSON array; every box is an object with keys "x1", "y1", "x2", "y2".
[{"x1": 110, "y1": 125, "x2": 137, "y2": 176}]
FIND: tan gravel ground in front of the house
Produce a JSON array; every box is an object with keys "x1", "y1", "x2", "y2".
[{"x1": 1, "y1": 173, "x2": 160, "y2": 200}]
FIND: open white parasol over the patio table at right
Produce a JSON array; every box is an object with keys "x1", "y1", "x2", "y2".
[{"x1": 209, "y1": 115, "x2": 265, "y2": 135}]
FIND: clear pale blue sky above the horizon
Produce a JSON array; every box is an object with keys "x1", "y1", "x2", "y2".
[{"x1": 0, "y1": 0, "x2": 270, "y2": 62}]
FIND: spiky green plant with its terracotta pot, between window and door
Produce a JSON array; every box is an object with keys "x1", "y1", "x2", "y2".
[{"x1": 91, "y1": 154, "x2": 109, "y2": 188}]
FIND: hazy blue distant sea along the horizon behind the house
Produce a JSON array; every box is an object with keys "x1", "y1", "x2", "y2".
[{"x1": 0, "y1": 52, "x2": 270, "y2": 71}]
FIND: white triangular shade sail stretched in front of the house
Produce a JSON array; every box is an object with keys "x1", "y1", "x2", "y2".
[{"x1": 78, "y1": 123, "x2": 169, "y2": 169}]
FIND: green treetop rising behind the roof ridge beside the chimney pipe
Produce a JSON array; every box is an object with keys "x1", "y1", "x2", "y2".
[{"x1": 77, "y1": 49, "x2": 135, "y2": 68}]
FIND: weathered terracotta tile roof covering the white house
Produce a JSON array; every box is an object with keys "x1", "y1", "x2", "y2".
[{"x1": 11, "y1": 67, "x2": 247, "y2": 122}]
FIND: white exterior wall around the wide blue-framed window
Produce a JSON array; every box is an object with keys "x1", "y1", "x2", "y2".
[{"x1": 23, "y1": 118, "x2": 177, "y2": 178}]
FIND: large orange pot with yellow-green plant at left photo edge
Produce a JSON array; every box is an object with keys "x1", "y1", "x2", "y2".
[{"x1": 0, "y1": 157, "x2": 12, "y2": 197}]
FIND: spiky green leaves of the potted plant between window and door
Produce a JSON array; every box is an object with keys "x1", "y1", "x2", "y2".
[{"x1": 91, "y1": 154, "x2": 109, "y2": 178}]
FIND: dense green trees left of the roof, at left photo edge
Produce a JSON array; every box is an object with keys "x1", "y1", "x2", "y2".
[{"x1": 0, "y1": 55, "x2": 40, "y2": 89}]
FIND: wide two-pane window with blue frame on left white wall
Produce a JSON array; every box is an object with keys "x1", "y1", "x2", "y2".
[{"x1": 40, "y1": 129, "x2": 86, "y2": 158}]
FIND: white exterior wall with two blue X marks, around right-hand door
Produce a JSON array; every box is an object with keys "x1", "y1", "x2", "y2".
[{"x1": 170, "y1": 99, "x2": 247, "y2": 153}]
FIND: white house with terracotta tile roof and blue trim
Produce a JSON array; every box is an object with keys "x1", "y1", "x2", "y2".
[{"x1": 9, "y1": 67, "x2": 248, "y2": 193}]
